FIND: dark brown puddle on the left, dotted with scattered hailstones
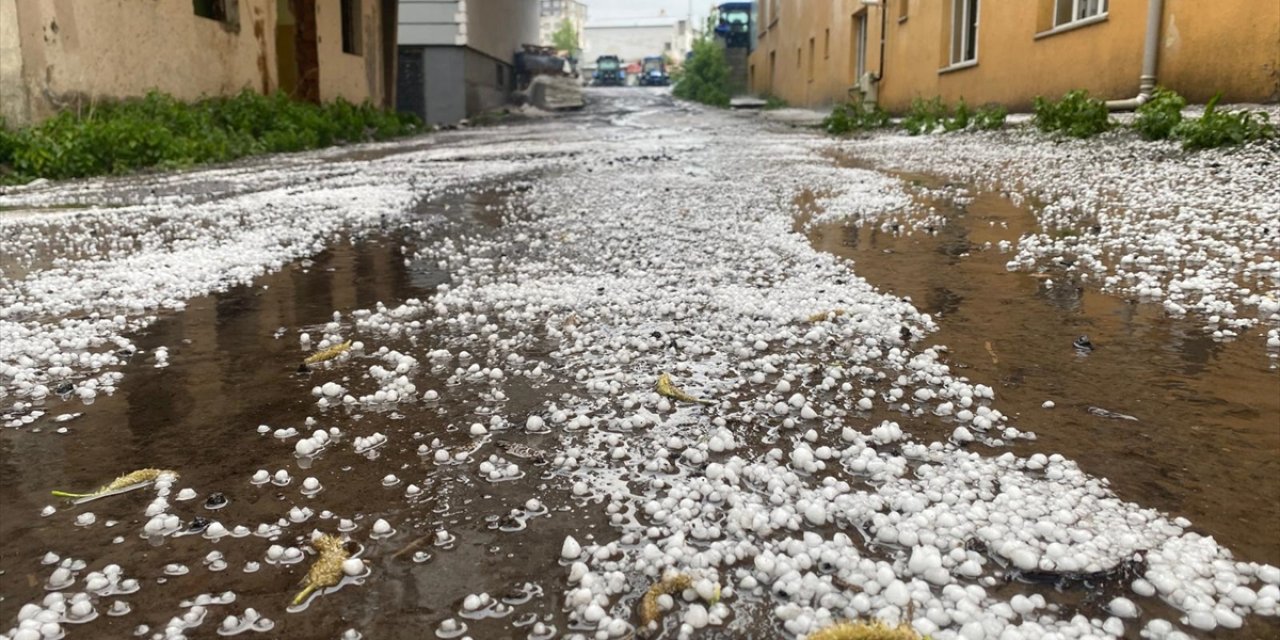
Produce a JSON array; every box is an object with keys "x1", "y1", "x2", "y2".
[{"x1": 0, "y1": 184, "x2": 617, "y2": 639}]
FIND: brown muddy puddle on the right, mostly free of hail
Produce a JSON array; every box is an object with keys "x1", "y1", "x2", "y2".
[{"x1": 801, "y1": 177, "x2": 1280, "y2": 564}]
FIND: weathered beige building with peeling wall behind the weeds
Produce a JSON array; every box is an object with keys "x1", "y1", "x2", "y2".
[{"x1": 0, "y1": 0, "x2": 396, "y2": 125}]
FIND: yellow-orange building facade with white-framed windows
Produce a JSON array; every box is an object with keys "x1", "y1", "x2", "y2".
[{"x1": 749, "y1": 0, "x2": 1280, "y2": 113}]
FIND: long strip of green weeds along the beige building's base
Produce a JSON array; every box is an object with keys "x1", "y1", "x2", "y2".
[{"x1": 0, "y1": 91, "x2": 421, "y2": 180}]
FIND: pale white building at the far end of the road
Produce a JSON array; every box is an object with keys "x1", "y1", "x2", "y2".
[{"x1": 582, "y1": 18, "x2": 694, "y2": 68}]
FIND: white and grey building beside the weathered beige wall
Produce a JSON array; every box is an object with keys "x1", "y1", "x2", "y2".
[{"x1": 397, "y1": 0, "x2": 540, "y2": 124}]
